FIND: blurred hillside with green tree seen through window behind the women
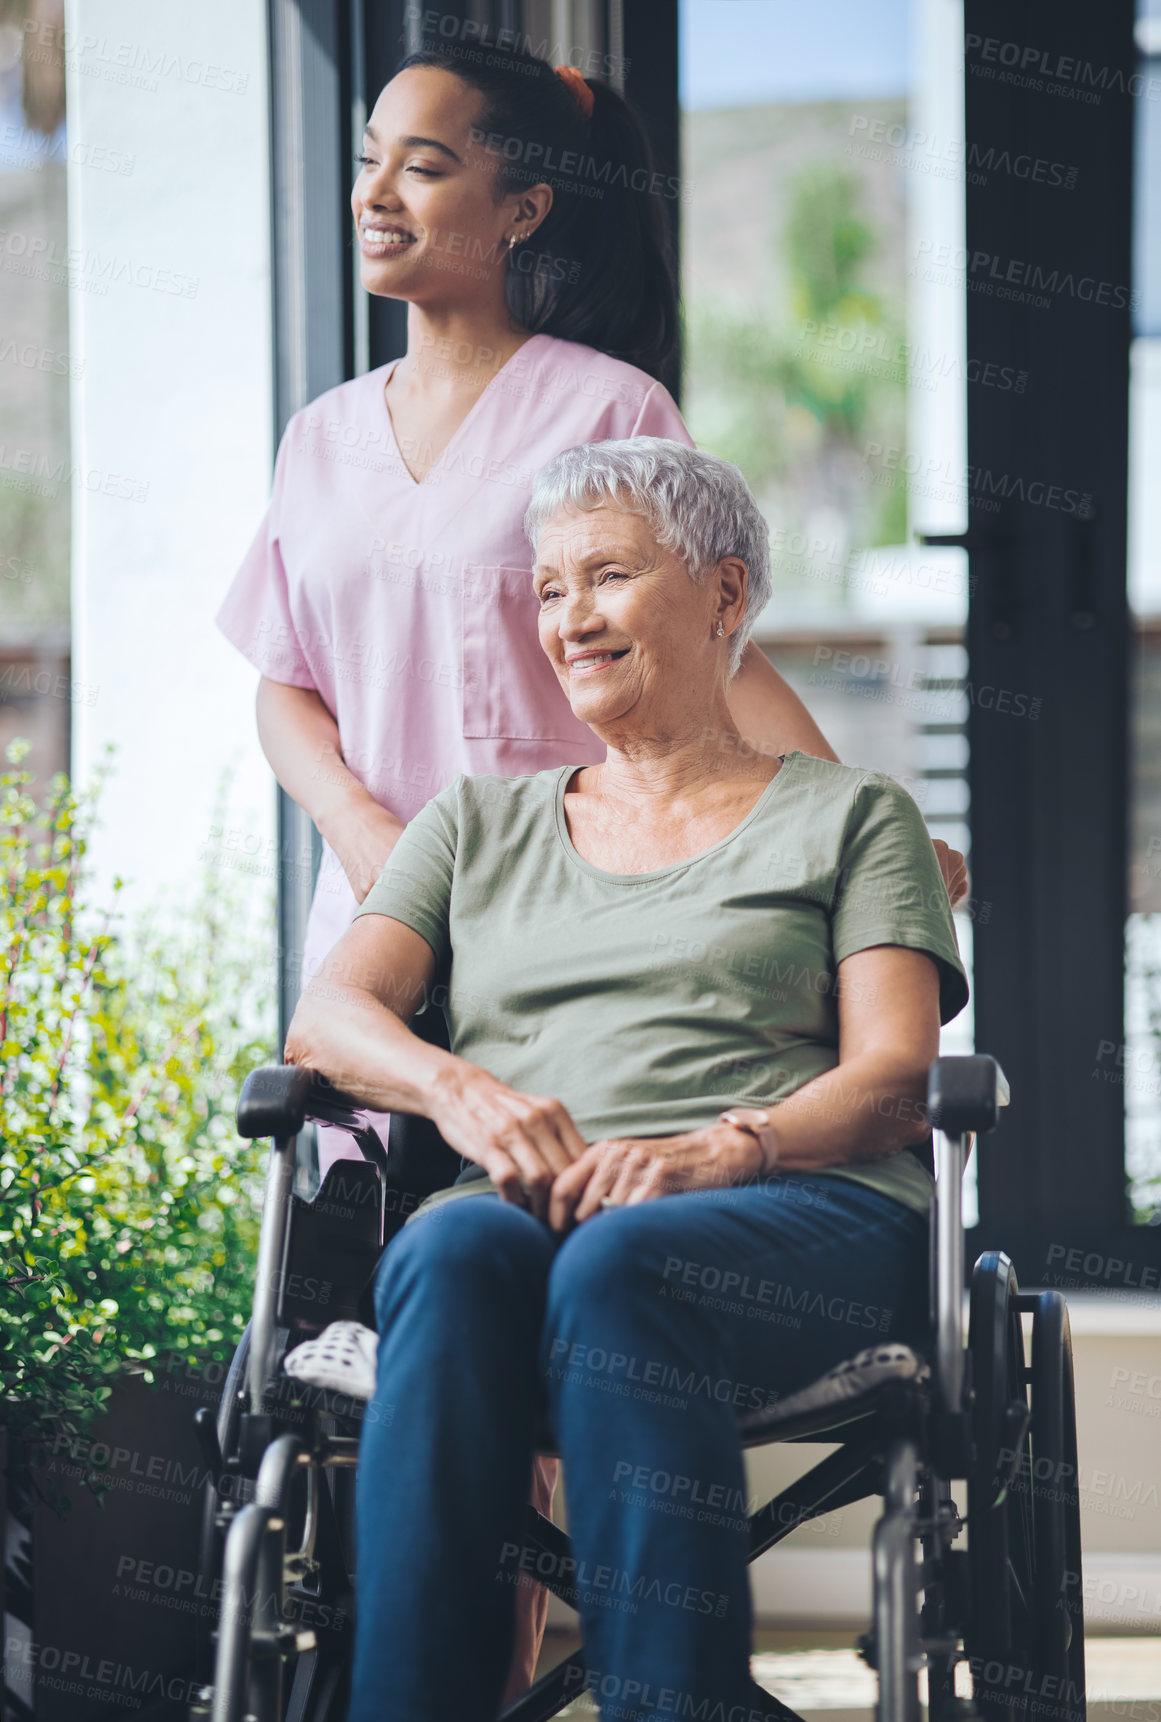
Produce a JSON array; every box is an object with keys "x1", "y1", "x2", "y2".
[{"x1": 682, "y1": 96, "x2": 906, "y2": 585}]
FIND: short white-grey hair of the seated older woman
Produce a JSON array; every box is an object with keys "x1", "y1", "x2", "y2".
[{"x1": 524, "y1": 436, "x2": 770, "y2": 678}]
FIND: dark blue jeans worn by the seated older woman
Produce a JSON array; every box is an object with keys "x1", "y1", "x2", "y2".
[{"x1": 350, "y1": 1173, "x2": 927, "y2": 1722}]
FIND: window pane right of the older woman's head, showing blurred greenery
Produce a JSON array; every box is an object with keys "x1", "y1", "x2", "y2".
[{"x1": 680, "y1": 0, "x2": 978, "y2": 1223}]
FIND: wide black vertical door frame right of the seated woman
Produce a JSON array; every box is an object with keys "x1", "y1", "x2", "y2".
[{"x1": 953, "y1": 0, "x2": 1136, "y2": 1288}]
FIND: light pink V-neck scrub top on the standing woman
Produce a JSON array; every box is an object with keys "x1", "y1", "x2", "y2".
[{"x1": 215, "y1": 334, "x2": 694, "y2": 1169}]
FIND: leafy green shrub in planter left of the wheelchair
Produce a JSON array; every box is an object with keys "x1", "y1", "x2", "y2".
[{"x1": 0, "y1": 742, "x2": 274, "y2": 1494}]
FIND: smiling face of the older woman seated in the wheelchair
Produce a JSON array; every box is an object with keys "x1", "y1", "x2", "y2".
[{"x1": 532, "y1": 506, "x2": 746, "y2": 735}]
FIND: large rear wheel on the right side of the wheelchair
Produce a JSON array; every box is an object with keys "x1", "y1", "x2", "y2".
[{"x1": 965, "y1": 1252, "x2": 1085, "y2": 1722}]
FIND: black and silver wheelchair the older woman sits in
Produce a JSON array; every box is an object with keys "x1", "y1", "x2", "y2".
[{"x1": 189, "y1": 1056, "x2": 1085, "y2": 1722}]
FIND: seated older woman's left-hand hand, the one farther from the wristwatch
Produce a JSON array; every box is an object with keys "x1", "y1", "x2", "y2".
[{"x1": 427, "y1": 1059, "x2": 586, "y2": 1219}]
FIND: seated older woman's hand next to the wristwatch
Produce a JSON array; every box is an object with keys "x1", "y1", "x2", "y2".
[{"x1": 548, "y1": 1124, "x2": 763, "y2": 1231}]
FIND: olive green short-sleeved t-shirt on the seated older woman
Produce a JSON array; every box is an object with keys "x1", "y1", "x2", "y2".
[{"x1": 358, "y1": 753, "x2": 968, "y2": 1212}]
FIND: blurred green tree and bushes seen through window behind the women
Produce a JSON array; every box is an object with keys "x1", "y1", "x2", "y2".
[{"x1": 686, "y1": 160, "x2": 906, "y2": 571}]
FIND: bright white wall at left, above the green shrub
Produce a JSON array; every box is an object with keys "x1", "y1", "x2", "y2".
[{"x1": 65, "y1": 0, "x2": 274, "y2": 902}]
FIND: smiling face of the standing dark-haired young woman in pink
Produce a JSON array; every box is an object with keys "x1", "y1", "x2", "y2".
[{"x1": 351, "y1": 65, "x2": 551, "y2": 303}]
